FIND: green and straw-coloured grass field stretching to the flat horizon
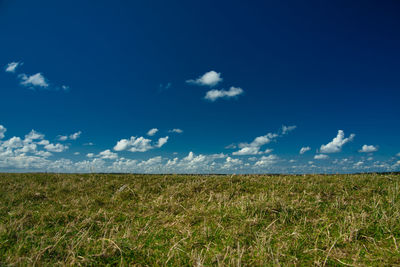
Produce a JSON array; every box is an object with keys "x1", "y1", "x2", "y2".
[{"x1": 0, "y1": 174, "x2": 400, "y2": 266}]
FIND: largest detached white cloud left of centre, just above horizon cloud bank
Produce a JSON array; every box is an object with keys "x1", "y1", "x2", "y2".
[{"x1": 114, "y1": 136, "x2": 169, "y2": 152}]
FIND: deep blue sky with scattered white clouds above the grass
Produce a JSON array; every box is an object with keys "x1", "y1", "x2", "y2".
[{"x1": 0, "y1": 0, "x2": 400, "y2": 173}]
